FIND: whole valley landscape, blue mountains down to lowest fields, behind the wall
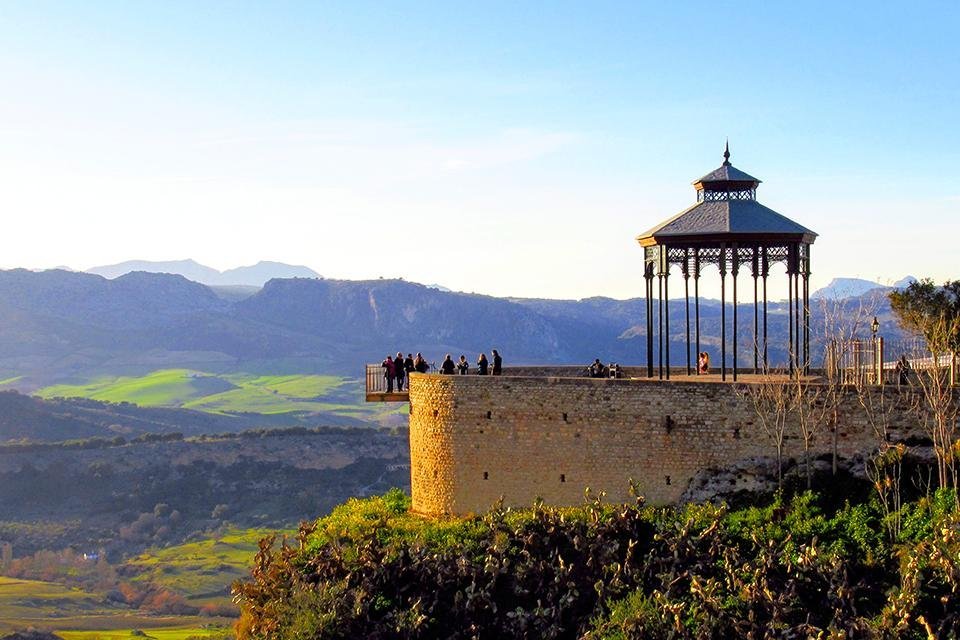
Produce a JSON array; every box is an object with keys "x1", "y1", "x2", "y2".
[{"x1": 0, "y1": 270, "x2": 920, "y2": 640}]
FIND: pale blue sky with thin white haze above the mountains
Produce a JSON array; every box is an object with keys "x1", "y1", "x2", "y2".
[{"x1": 0, "y1": 0, "x2": 960, "y2": 298}]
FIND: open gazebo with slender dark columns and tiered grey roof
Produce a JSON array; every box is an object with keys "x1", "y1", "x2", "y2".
[{"x1": 637, "y1": 143, "x2": 817, "y2": 381}]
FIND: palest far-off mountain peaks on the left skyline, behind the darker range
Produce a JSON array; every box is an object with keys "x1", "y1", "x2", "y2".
[{"x1": 86, "y1": 260, "x2": 320, "y2": 287}]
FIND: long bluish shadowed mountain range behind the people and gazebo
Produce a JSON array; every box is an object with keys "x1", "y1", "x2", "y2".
[{"x1": 0, "y1": 269, "x2": 916, "y2": 390}]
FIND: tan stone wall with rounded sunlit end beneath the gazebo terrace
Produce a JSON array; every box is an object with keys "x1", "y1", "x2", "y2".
[{"x1": 410, "y1": 372, "x2": 928, "y2": 515}]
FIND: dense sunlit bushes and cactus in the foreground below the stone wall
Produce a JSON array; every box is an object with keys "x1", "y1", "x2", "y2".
[{"x1": 234, "y1": 491, "x2": 960, "y2": 640}]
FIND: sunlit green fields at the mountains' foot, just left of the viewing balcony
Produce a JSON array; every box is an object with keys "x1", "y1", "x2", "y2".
[{"x1": 36, "y1": 369, "x2": 403, "y2": 421}]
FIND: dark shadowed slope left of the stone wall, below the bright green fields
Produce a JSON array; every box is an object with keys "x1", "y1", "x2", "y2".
[{"x1": 0, "y1": 428, "x2": 410, "y2": 556}]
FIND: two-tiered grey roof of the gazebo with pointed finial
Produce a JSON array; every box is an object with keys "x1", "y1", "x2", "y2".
[{"x1": 637, "y1": 144, "x2": 817, "y2": 247}]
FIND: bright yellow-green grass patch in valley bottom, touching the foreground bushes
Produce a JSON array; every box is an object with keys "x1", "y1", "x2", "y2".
[{"x1": 126, "y1": 529, "x2": 282, "y2": 606}]
